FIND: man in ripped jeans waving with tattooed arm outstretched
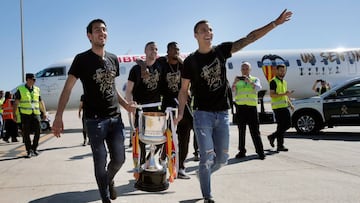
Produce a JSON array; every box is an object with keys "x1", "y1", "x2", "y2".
[{"x1": 175, "y1": 10, "x2": 292, "y2": 202}]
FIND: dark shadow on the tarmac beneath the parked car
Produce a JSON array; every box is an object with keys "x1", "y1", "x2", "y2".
[{"x1": 285, "y1": 132, "x2": 360, "y2": 142}]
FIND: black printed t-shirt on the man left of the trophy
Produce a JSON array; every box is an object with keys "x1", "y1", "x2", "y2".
[{"x1": 68, "y1": 49, "x2": 120, "y2": 118}]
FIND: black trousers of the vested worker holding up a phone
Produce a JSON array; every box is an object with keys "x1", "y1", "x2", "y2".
[{"x1": 236, "y1": 105, "x2": 264, "y2": 154}]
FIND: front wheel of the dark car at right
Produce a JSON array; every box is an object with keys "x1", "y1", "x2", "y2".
[{"x1": 293, "y1": 111, "x2": 322, "y2": 134}]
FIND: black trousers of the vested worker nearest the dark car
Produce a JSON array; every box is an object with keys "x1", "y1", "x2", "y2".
[{"x1": 270, "y1": 108, "x2": 291, "y2": 147}]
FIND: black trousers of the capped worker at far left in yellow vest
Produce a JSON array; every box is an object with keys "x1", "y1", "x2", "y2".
[{"x1": 21, "y1": 114, "x2": 40, "y2": 152}]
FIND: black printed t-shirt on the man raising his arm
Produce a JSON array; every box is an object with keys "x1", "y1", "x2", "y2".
[{"x1": 181, "y1": 42, "x2": 233, "y2": 111}]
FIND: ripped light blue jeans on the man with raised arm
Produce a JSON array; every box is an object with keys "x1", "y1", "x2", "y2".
[{"x1": 194, "y1": 111, "x2": 229, "y2": 198}]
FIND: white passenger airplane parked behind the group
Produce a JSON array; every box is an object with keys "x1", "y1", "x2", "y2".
[{"x1": 32, "y1": 48, "x2": 360, "y2": 110}]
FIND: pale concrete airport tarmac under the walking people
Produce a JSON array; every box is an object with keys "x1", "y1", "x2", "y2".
[{"x1": 0, "y1": 110, "x2": 360, "y2": 203}]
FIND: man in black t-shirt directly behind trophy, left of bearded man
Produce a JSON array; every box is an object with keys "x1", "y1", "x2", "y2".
[{"x1": 125, "y1": 42, "x2": 163, "y2": 164}]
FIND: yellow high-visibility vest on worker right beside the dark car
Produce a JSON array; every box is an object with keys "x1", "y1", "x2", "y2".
[{"x1": 270, "y1": 77, "x2": 289, "y2": 109}]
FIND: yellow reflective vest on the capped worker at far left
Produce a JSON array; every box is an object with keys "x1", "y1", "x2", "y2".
[{"x1": 18, "y1": 85, "x2": 40, "y2": 115}]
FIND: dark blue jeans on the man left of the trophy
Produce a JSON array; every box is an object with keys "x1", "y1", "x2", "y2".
[{"x1": 86, "y1": 116, "x2": 125, "y2": 200}]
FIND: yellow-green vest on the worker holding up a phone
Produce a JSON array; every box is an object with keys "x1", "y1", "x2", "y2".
[{"x1": 235, "y1": 76, "x2": 258, "y2": 106}]
